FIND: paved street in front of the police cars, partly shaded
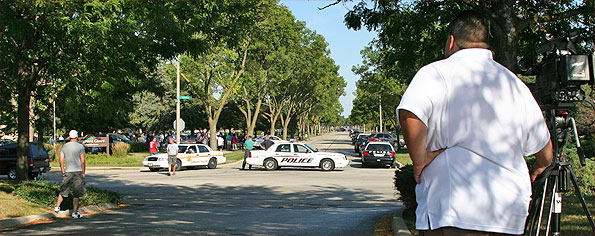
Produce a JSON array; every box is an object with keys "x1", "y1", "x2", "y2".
[{"x1": 2, "y1": 133, "x2": 401, "y2": 235}]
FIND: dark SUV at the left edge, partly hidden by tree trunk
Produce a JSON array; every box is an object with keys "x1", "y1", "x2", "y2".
[{"x1": 0, "y1": 142, "x2": 51, "y2": 179}]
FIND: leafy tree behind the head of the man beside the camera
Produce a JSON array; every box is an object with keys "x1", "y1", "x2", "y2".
[{"x1": 342, "y1": 1, "x2": 595, "y2": 133}]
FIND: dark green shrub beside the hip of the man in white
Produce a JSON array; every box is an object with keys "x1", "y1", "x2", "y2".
[{"x1": 394, "y1": 165, "x2": 417, "y2": 210}]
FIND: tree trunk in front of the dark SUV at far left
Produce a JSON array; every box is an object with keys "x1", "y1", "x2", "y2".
[{"x1": 16, "y1": 78, "x2": 32, "y2": 181}]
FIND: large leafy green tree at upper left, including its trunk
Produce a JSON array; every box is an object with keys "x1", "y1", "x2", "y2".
[{"x1": 0, "y1": 1, "x2": 258, "y2": 180}]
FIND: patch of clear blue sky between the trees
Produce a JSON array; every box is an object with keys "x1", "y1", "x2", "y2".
[{"x1": 281, "y1": 0, "x2": 376, "y2": 117}]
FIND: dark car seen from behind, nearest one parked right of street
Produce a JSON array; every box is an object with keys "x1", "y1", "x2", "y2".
[{"x1": 362, "y1": 142, "x2": 396, "y2": 168}]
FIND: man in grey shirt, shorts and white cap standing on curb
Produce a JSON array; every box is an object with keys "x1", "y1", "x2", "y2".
[{"x1": 54, "y1": 130, "x2": 86, "y2": 219}]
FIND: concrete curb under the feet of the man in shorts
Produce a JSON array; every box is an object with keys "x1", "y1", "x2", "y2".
[{"x1": 0, "y1": 203, "x2": 125, "y2": 231}]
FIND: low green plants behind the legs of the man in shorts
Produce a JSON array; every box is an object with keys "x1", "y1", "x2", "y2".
[{"x1": 12, "y1": 181, "x2": 122, "y2": 209}]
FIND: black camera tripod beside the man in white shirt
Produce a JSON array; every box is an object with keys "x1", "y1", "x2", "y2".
[{"x1": 525, "y1": 109, "x2": 595, "y2": 236}]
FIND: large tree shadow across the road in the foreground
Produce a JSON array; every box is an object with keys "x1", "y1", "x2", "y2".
[{"x1": 2, "y1": 171, "x2": 400, "y2": 235}]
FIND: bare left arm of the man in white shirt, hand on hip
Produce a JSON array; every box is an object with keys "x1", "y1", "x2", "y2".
[{"x1": 399, "y1": 110, "x2": 444, "y2": 184}]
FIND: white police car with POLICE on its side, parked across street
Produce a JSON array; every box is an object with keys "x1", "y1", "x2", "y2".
[{"x1": 246, "y1": 142, "x2": 349, "y2": 171}]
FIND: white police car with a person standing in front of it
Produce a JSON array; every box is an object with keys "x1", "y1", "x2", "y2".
[{"x1": 143, "y1": 144, "x2": 227, "y2": 172}]
